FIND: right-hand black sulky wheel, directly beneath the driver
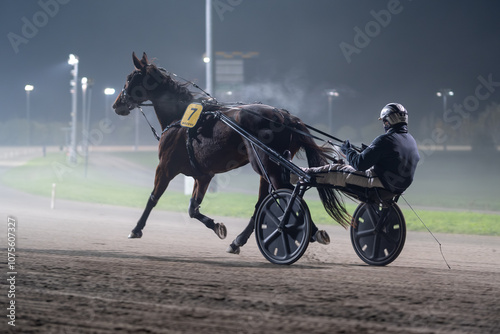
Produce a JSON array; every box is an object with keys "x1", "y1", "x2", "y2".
[{"x1": 351, "y1": 203, "x2": 406, "y2": 266}]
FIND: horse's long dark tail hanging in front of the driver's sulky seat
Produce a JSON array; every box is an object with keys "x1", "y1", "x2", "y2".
[{"x1": 293, "y1": 122, "x2": 352, "y2": 228}]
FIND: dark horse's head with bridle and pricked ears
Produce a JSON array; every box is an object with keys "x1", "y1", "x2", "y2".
[{"x1": 113, "y1": 53, "x2": 178, "y2": 116}]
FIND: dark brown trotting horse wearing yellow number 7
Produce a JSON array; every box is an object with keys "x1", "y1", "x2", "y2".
[{"x1": 113, "y1": 53, "x2": 349, "y2": 254}]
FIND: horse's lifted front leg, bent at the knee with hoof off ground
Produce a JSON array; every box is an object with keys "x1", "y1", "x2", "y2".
[{"x1": 188, "y1": 176, "x2": 227, "y2": 239}]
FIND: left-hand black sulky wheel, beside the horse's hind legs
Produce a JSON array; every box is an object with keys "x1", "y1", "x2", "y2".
[{"x1": 255, "y1": 189, "x2": 311, "y2": 264}]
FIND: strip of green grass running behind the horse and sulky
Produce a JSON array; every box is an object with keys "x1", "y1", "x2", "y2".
[{"x1": 1, "y1": 154, "x2": 500, "y2": 236}]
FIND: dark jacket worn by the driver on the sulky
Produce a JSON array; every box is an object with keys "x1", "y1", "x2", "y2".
[{"x1": 346, "y1": 124, "x2": 420, "y2": 194}]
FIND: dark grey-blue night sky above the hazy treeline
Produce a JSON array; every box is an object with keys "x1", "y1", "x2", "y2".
[{"x1": 0, "y1": 0, "x2": 500, "y2": 138}]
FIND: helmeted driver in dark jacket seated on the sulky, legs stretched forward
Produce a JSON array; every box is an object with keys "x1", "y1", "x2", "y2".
[{"x1": 303, "y1": 103, "x2": 420, "y2": 194}]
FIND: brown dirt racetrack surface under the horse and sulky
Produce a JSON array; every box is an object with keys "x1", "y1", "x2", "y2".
[{"x1": 0, "y1": 156, "x2": 500, "y2": 334}]
